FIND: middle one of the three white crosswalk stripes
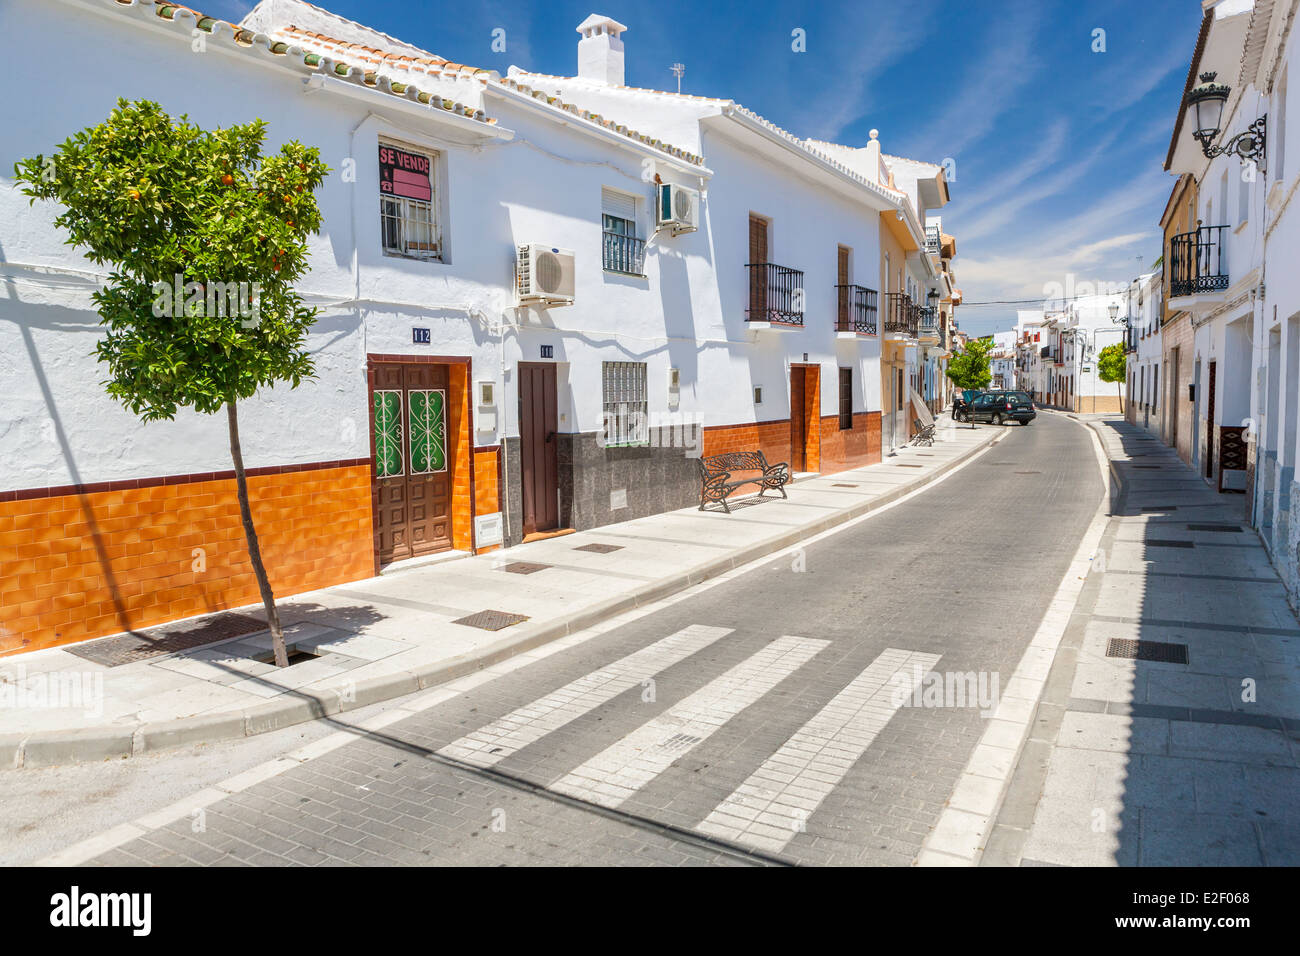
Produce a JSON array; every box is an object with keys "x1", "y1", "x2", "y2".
[{"x1": 550, "y1": 636, "x2": 829, "y2": 808}]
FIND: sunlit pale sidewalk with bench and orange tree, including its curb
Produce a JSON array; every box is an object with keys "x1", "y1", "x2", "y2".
[{"x1": 0, "y1": 416, "x2": 1008, "y2": 769}]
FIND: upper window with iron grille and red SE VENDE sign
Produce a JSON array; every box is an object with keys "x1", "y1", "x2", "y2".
[{"x1": 380, "y1": 142, "x2": 442, "y2": 260}]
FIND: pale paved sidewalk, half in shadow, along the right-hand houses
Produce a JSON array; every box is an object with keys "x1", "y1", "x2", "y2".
[{"x1": 982, "y1": 416, "x2": 1300, "y2": 866}]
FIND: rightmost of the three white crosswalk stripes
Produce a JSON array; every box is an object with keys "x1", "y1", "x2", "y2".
[{"x1": 696, "y1": 648, "x2": 939, "y2": 852}]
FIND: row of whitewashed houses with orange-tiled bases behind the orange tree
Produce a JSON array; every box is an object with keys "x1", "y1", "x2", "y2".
[{"x1": 0, "y1": 0, "x2": 946, "y2": 653}]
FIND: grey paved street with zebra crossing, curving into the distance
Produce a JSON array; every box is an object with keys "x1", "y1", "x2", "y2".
[{"x1": 12, "y1": 415, "x2": 1102, "y2": 865}]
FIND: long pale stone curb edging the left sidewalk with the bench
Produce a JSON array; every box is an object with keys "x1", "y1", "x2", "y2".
[{"x1": 0, "y1": 431, "x2": 1008, "y2": 771}]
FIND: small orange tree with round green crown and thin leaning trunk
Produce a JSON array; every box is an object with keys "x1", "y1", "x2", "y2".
[{"x1": 14, "y1": 100, "x2": 329, "y2": 667}]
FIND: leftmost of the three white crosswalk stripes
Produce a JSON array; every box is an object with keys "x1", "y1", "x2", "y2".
[{"x1": 438, "y1": 624, "x2": 735, "y2": 767}]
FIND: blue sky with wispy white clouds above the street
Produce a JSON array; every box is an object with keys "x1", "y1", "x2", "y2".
[{"x1": 208, "y1": 0, "x2": 1200, "y2": 343}]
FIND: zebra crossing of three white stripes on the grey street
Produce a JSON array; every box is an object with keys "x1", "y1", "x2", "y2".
[{"x1": 438, "y1": 624, "x2": 940, "y2": 852}]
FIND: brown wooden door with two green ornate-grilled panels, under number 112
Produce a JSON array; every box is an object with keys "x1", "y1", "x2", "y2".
[{"x1": 371, "y1": 363, "x2": 451, "y2": 564}]
